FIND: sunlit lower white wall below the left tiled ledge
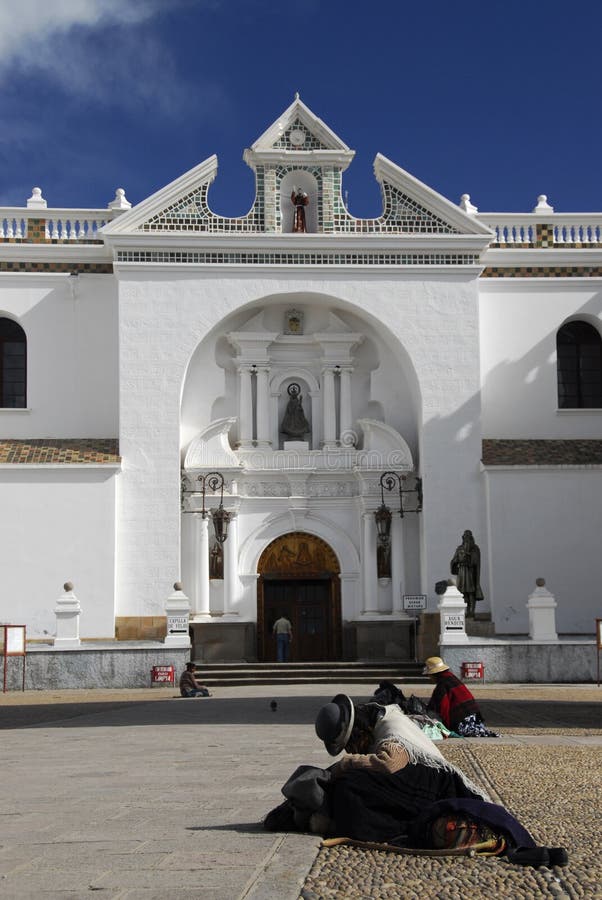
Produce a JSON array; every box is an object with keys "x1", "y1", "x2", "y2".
[{"x1": 0, "y1": 466, "x2": 117, "y2": 640}]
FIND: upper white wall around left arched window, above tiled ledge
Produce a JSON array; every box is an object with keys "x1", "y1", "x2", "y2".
[{"x1": 0, "y1": 273, "x2": 119, "y2": 438}]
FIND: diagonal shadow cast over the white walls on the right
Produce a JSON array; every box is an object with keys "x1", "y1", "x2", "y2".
[{"x1": 422, "y1": 292, "x2": 602, "y2": 635}]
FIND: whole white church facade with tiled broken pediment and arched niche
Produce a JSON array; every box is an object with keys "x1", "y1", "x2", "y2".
[{"x1": 0, "y1": 98, "x2": 602, "y2": 661}]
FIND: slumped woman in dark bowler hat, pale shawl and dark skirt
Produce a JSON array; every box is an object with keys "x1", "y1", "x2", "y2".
[{"x1": 264, "y1": 694, "x2": 567, "y2": 865}]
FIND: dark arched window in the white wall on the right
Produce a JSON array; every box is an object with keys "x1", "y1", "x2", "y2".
[{"x1": 556, "y1": 322, "x2": 602, "y2": 409}]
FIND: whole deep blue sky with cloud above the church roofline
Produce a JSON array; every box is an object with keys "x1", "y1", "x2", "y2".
[{"x1": 0, "y1": 0, "x2": 602, "y2": 216}]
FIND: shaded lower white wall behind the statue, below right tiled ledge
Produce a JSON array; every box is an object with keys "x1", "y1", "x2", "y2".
[{"x1": 483, "y1": 466, "x2": 602, "y2": 634}]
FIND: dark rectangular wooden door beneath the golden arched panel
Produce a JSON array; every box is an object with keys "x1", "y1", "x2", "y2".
[{"x1": 262, "y1": 578, "x2": 333, "y2": 662}]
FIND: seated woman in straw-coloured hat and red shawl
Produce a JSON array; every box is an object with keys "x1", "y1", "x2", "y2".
[{"x1": 422, "y1": 656, "x2": 498, "y2": 737}]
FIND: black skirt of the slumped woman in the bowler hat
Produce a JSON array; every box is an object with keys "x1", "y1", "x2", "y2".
[{"x1": 330, "y1": 763, "x2": 482, "y2": 841}]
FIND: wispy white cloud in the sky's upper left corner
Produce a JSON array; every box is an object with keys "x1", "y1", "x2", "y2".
[{"x1": 0, "y1": 0, "x2": 220, "y2": 116}]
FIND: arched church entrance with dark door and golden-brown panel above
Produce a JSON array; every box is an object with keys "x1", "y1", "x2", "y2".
[{"x1": 257, "y1": 531, "x2": 341, "y2": 662}]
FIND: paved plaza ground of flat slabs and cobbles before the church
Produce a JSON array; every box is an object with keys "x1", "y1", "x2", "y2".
[{"x1": 0, "y1": 685, "x2": 602, "y2": 900}]
